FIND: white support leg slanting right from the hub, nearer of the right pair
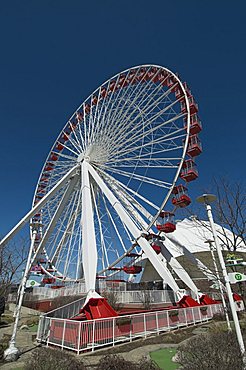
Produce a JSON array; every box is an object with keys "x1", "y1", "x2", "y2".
[{"x1": 88, "y1": 163, "x2": 183, "y2": 298}]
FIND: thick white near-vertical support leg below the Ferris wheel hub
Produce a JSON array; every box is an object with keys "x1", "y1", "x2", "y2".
[{"x1": 81, "y1": 160, "x2": 100, "y2": 298}]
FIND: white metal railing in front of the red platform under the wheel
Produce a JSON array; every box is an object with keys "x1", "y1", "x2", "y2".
[{"x1": 37, "y1": 304, "x2": 222, "y2": 354}]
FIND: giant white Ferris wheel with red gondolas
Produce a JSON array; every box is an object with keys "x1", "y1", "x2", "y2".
[{"x1": 0, "y1": 65, "x2": 201, "y2": 298}]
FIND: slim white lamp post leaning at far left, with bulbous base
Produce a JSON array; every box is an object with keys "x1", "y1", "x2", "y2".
[{"x1": 4, "y1": 226, "x2": 38, "y2": 361}]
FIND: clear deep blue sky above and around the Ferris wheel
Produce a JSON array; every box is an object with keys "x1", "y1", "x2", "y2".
[{"x1": 0, "y1": 0, "x2": 246, "y2": 236}]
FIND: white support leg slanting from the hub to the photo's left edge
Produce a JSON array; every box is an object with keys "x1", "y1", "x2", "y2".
[{"x1": 0, "y1": 166, "x2": 78, "y2": 250}]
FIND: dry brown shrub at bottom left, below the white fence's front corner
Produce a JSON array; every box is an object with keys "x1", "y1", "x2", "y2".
[{"x1": 24, "y1": 347, "x2": 85, "y2": 370}]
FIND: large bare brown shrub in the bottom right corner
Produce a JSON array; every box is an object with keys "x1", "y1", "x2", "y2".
[{"x1": 177, "y1": 332, "x2": 244, "y2": 370}]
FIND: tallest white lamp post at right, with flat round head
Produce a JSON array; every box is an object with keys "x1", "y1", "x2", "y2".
[{"x1": 197, "y1": 194, "x2": 245, "y2": 356}]
